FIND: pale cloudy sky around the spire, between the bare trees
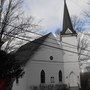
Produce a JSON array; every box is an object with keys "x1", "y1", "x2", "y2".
[{"x1": 24, "y1": 0, "x2": 89, "y2": 31}]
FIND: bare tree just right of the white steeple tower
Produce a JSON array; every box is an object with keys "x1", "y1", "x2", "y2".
[{"x1": 77, "y1": 32, "x2": 89, "y2": 71}]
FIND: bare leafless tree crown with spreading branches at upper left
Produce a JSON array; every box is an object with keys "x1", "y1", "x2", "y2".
[{"x1": 0, "y1": 0, "x2": 38, "y2": 51}]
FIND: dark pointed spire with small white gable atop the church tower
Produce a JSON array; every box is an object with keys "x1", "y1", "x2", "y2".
[{"x1": 61, "y1": 0, "x2": 76, "y2": 35}]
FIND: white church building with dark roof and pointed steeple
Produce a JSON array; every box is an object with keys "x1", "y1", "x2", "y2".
[{"x1": 12, "y1": 1, "x2": 80, "y2": 90}]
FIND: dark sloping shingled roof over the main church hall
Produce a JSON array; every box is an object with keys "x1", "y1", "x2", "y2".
[{"x1": 15, "y1": 33, "x2": 50, "y2": 65}]
